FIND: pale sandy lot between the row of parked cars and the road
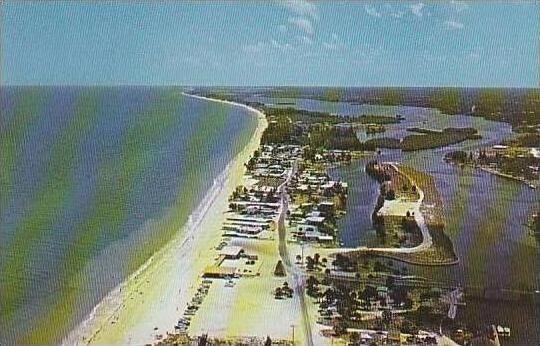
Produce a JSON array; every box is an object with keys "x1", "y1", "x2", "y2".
[{"x1": 189, "y1": 237, "x2": 302, "y2": 344}]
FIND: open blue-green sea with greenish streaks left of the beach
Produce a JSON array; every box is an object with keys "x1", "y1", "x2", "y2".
[{"x1": 0, "y1": 87, "x2": 256, "y2": 344}]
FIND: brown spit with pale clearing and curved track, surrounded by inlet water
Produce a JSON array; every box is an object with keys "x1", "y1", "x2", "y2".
[{"x1": 350, "y1": 161, "x2": 458, "y2": 266}]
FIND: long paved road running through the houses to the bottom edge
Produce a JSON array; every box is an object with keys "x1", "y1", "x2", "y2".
[{"x1": 277, "y1": 163, "x2": 313, "y2": 346}]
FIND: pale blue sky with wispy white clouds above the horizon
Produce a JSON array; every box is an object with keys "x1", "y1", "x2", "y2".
[{"x1": 0, "y1": 0, "x2": 540, "y2": 87}]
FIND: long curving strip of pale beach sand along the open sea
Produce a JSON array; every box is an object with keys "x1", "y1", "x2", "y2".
[{"x1": 62, "y1": 92, "x2": 267, "y2": 345}]
